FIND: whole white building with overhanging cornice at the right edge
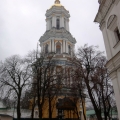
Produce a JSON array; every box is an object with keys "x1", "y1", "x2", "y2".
[{"x1": 95, "y1": 0, "x2": 120, "y2": 119}]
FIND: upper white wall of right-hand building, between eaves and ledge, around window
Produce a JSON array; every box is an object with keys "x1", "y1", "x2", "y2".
[{"x1": 102, "y1": 2, "x2": 120, "y2": 60}]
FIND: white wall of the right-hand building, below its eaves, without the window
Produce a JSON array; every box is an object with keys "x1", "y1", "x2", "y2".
[{"x1": 101, "y1": 0, "x2": 120, "y2": 119}]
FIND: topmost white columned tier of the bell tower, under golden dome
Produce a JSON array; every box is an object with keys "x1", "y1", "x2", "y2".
[{"x1": 46, "y1": 3, "x2": 70, "y2": 31}]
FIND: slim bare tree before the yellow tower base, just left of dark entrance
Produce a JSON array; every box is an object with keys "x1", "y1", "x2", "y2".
[{"x1": 46, "y1": 66, "x2": 64, "y2": 120}]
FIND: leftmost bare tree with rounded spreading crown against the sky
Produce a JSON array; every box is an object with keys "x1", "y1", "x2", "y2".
[{"x1": 0, "y1": 55, "x2": 31, "y2": 120}]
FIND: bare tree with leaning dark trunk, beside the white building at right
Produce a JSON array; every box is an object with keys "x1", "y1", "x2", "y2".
[{"x1": 73, "y1": 45, "x2": 113, "y2": 120}]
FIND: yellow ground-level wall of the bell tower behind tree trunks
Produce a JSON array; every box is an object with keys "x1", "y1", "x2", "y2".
[{"x1": 30, "y1": 96, "x2": 86, "y2": 120}]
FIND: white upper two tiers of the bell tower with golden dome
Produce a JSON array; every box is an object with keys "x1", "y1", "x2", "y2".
[{"x1": 39, "y1": 0, "x2": 76, "y2": 57}]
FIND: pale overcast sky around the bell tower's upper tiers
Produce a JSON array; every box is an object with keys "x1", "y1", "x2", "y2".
[{"x1": 0, "y1": 0, "x2": 105, "y2": 61}]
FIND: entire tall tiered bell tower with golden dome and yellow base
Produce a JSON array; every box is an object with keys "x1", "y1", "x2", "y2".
[{"x1": 39, "y1": 0, "x2": 82, "y2": 119}]
